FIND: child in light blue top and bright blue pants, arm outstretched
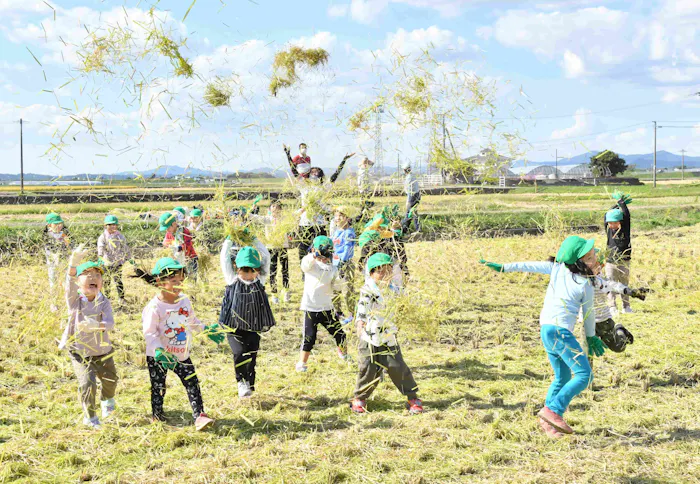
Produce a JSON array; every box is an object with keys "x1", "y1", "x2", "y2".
[{"x1": 480, "y1": 235, "x2": 605, "y2": 438}]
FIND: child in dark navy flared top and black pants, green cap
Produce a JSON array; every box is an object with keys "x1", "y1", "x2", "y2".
[{"x1": 219, "y1": 246, "x2": 275, "y2": 398}]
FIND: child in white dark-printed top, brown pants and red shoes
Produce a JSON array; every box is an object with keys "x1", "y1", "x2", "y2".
[{"x1": 350, "y1": 253, "x2": 423, "y2": 414}]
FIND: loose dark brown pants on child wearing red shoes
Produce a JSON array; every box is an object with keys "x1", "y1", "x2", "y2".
[{"x1": 355, "y1": 339, "x2": 418, "y2": 400}]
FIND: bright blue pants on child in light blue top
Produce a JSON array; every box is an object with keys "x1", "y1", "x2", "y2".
[{"x1": 540, "y1": 324, "x2": 593, "y2": 415}]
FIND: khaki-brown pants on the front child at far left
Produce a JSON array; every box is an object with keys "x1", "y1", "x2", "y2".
[{"x1": 71, "y1": 353, "x2": 119, "y2": 418}]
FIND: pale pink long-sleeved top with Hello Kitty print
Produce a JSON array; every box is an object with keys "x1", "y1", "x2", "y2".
[{"x1": 141, "y1": 294, "x2": 204, "y2": 361}]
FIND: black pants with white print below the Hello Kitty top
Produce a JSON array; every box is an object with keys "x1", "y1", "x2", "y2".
[{"x1": 146, "y1": 356, "x2": 204, "y2": 420}]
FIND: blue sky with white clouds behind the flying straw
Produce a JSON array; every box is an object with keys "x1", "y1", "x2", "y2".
[{"x1": 0, "y1": 0, "x2": 700, "y2": 175}]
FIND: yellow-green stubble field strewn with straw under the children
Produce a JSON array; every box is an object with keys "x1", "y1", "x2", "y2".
[{"x1": 0, "y1": 225, "x2": 700, "y2": 483}]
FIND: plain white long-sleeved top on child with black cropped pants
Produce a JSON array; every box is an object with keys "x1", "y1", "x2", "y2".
[{"x1": 299, "y1": 254, "x2": 344, "y2": 312}]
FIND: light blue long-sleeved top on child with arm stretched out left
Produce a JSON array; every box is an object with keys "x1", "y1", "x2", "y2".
[{"x1": 503, "y1": 262, "x2": 595, "y2": 336}]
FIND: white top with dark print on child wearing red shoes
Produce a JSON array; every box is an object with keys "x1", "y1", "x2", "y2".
[{"x1": 357, "y1": 277, "x2": 399, "y2": 346}]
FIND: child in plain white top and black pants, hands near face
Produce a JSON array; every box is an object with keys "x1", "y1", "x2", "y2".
[{"x1": 296, "y1": 235, "x2": 350, "y2": 372}]
